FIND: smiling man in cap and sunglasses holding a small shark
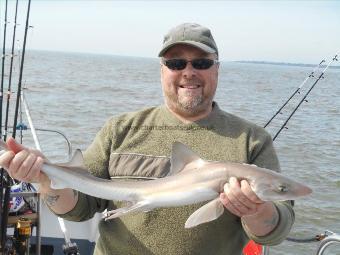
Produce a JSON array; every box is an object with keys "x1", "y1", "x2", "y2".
[{"x1": 0, "y1": 23, "x2": 294, "y2": 255}]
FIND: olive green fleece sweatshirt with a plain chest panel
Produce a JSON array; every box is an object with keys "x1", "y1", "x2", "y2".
[{"x1": 62, "y1": 103, "x2": 294, "y2": 255}]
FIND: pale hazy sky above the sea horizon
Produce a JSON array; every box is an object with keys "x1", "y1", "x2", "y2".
[{"x1": 0, "y1": 0, "x2": 340, "y2": 64}]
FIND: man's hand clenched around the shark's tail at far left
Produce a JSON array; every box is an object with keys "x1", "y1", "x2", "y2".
[{"x1": 0, "y1": 138, "x2": 49, "y2": 183}]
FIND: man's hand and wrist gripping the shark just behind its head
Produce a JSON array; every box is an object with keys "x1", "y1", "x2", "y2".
[{"x1": 220, "y1": 177, "x2": 279, "y2": 236}]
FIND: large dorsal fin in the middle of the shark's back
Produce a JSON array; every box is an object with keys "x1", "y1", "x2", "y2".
[{"x1": 169, "y1": 142, "x2": 204, "y2": 175}]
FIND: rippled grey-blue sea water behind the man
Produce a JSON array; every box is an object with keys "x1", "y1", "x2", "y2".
[{"x1": 1, "y1": 51, "x2": 340, "y2": 255}]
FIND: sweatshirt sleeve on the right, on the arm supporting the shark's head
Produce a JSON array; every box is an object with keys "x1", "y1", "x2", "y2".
[{"x1": 242, "y1": 128, "x2": 295, "y2": 245}]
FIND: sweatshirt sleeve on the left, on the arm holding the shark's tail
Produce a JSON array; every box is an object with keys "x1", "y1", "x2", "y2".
[{"x1": 58, "y1": 119, "x2": 115, "y2": 221}]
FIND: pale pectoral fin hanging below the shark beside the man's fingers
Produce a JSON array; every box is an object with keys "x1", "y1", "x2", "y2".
[{"x1": 185, "y1": 197, "x2": 224, "y2": 228}]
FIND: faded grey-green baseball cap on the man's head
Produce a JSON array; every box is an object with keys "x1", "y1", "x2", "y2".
[{"x1": 158, "y1": 23, "x2": 218, "y2": 57}]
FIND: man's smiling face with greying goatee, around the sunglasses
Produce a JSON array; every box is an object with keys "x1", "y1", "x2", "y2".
[{"x1": 161, "y1": 44, "x2": 219, "y2": 117}]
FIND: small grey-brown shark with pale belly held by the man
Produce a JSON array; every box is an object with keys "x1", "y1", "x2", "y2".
[{"x1": 0, "y1": 141, "x2": 312, "y2": 228}]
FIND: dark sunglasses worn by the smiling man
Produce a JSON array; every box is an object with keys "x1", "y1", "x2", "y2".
[{"x1": 161, "y1": 58, "x2": 218, "y2": 70}]
